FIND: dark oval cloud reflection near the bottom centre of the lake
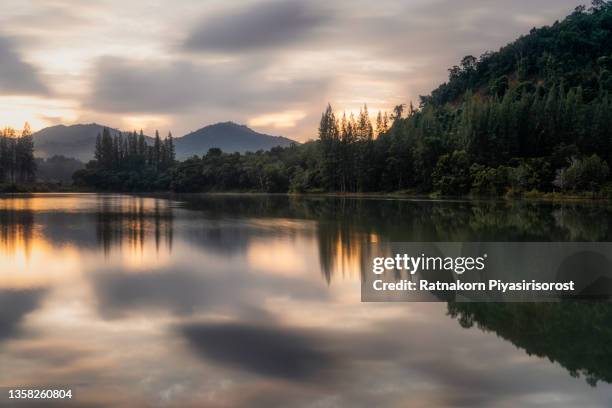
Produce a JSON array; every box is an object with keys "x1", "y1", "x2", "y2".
[{"x1": 180, "y1": 323, "x2": 335, "y2": 381}]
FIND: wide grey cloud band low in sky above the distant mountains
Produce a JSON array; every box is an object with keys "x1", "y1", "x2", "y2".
[{"x1": 87, "y1": 57, "x2": 329, "y2": 113}]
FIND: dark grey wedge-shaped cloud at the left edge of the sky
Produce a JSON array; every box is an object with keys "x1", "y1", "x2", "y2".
[{"x1": 0, "y1": 37, "x2": 48, "y2": 95}]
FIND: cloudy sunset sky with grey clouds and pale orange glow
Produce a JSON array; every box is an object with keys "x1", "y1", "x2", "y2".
[{"x1": 0, "y1": 0, "x2": 586, "y2": 141}]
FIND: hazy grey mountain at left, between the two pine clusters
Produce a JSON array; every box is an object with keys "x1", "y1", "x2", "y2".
[{"x1": 33, "y1": 123, "x2": 126, "y2": 162}]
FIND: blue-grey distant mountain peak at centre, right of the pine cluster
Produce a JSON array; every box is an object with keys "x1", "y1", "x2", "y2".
[{"x1": 175, "y1": 122, "x2": 296, "y2": 159}]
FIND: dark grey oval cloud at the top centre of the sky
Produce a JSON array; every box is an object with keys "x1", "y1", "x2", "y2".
[{"x1": 185, "y1": 1, "x2": 326, "y2": 53}]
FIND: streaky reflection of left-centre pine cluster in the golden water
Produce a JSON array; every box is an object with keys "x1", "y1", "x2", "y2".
[{"x1": 96, "y1": 197, "x2": 173, "y2": 254}]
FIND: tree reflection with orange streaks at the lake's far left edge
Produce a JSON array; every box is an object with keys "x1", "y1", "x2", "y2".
[{"x1": 0, "y1": 199, "x2": 34, "y2": 257}]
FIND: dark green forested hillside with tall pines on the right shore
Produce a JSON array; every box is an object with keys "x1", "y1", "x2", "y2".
[{"x1": 320, "y1": 1, "x2": 612, "y2": 195}]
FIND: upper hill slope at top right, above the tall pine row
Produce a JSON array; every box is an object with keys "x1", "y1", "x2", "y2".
[{"x1": 428, "y1": 0, "x2": 612, "y2": 106}]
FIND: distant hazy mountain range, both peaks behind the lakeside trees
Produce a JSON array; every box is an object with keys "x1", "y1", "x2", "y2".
[{"x1": 33, "y1": 122, "x2": 297, "y2": 162}]
